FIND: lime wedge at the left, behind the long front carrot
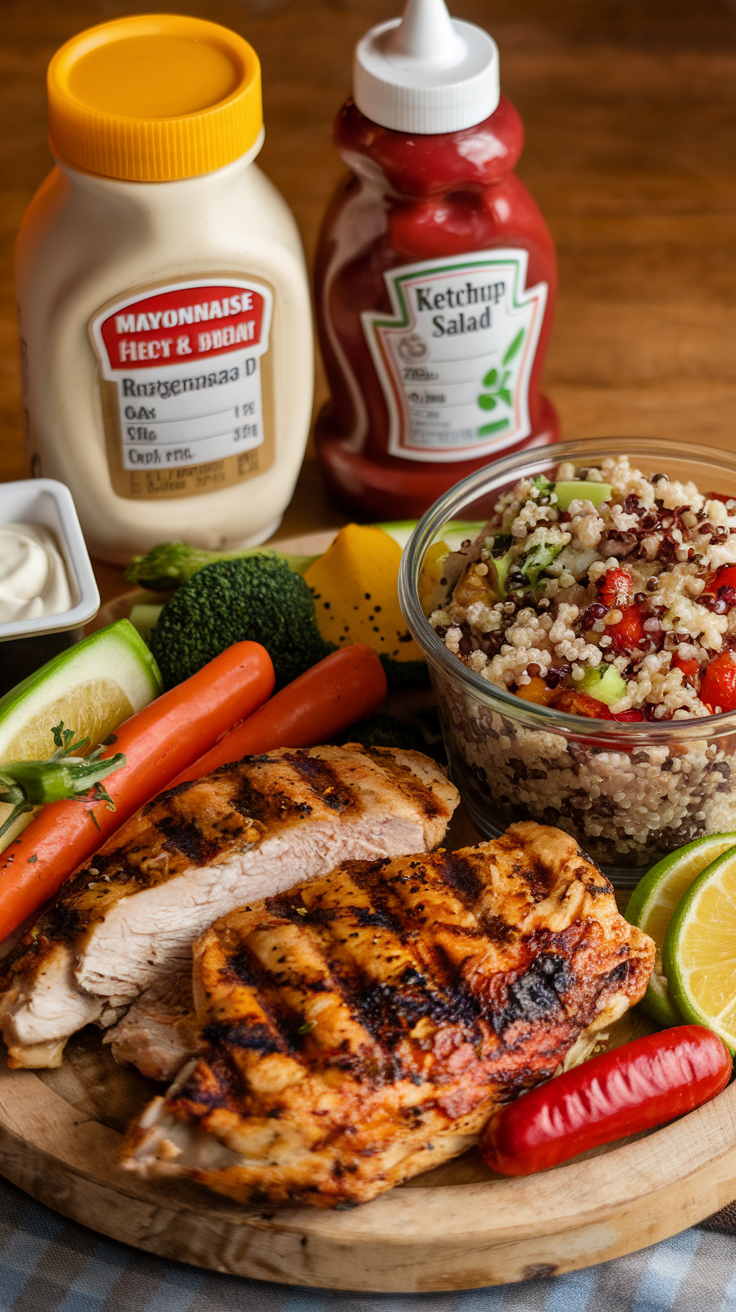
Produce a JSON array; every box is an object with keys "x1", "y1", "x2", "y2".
[{"x1": 0, "y1": 619, "x2": 161, "y2": 851}]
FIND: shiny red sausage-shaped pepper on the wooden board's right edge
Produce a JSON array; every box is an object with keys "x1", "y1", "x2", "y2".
[{"x1": 480, "y1": 1025, "x2": 732, "y2": 1176}]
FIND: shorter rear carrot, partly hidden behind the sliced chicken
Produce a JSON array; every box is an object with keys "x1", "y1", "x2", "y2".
[{"x1": 174, "y1": 643, "x2": 386, "y2": 783}]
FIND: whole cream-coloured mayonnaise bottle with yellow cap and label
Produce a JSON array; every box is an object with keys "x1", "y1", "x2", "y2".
[{"x1": 17, "y1": 14, "x2": 312, "y2": 563}]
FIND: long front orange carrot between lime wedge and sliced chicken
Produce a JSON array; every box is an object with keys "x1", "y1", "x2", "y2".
[{"x1": 0, "y1": 643, "x2": 274, "y2": 939}]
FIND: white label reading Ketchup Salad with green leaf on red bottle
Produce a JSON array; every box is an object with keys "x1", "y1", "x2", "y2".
[{"x1": 362, "y1": 248, "x2": 548, "y2": 461}]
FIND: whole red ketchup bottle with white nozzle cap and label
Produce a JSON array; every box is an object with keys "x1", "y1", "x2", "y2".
[{"x1": 315, "y1": 0, "x2": 558, "y2": 520}]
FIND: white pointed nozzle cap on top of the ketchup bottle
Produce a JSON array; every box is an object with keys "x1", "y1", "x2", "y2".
[{"x1": 353, "y1": 0, "x2": 499, "y2": 134}]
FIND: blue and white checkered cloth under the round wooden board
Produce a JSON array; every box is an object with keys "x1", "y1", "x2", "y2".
[{"x1": 0, "y1": 1179, "x2": 736, "y2": 1312}]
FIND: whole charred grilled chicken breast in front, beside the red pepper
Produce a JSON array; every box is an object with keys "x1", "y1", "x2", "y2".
[{"x1": 125, "y1": 823, "x2": 655, "y2": 1207}]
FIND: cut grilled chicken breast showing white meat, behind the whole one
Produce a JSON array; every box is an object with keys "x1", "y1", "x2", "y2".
[{"x1": 0, "y1": 744, "x2": 458, "y2": 1067}]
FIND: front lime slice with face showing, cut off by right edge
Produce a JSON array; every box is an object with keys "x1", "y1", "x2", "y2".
[{"x1": 663, "y1": 848, "x2": 736, "y2": 1052}]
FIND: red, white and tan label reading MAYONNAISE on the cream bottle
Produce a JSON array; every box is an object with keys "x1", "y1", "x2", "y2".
[{"x1": 89, "y1": 278, "x2": 273, "y2": 497}]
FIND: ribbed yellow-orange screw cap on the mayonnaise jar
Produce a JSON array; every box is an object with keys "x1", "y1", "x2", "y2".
[{"x1": 47, "y1": 13, "x2": 264, "y2": 182}]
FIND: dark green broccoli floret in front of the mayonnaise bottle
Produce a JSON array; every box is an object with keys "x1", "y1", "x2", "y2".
[{"x1": 150, "y1": 552, "x2": 332, "y2": 689}]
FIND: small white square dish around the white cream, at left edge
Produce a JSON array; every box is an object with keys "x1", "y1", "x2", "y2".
[{"x1": 0, "y1": 479, "x2": 100, "y2": 695}]
